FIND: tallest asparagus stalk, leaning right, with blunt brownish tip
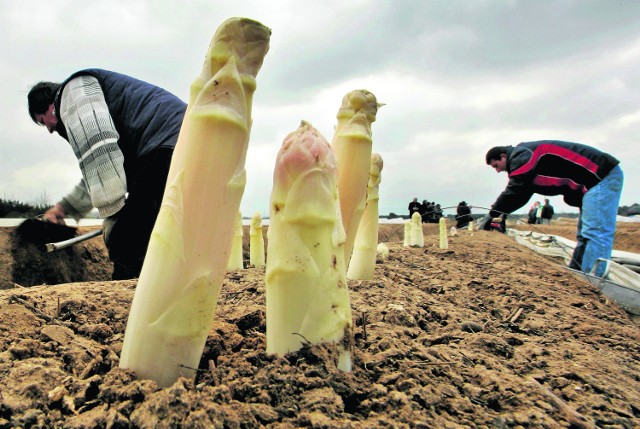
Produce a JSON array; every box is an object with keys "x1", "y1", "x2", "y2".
[{"x1": 120, "y1": 18, "x2": 271, "y2": 387}]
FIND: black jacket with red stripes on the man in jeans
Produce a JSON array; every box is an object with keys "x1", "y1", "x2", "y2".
[{"x1": 490, "y1": 140, "x2": 620, "y2": 217}]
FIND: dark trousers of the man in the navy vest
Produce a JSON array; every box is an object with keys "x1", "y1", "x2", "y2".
[{"x1": 105, "y1": 148, "x2": 173, "y2": 280}]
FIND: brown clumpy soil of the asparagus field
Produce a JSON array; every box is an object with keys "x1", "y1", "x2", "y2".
[{"x1": 0, "y1": 221, "x2": 640, "y2": 428}]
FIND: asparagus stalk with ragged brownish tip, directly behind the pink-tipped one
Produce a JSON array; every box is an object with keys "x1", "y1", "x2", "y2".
[{"x1": 331, "y1": 90, "x2": 381, "y2": 266}]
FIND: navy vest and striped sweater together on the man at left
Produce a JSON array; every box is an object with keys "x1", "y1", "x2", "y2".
[{"x1": 54, "y1": 69, "x2": 186, "y2": 219}]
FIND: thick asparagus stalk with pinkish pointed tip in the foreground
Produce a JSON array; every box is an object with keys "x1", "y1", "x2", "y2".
[{"x1": 266, "y1": 121, "x2": 353, "y2": 371}]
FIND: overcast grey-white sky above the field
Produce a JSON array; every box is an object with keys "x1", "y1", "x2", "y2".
[{"x1": 0, "y1": 0, "x2": 640, "y2": 217}]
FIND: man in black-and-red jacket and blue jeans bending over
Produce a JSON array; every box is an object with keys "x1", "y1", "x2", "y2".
[{"x1": 481, "y1": 140, "x2": 624, "y2": 276}]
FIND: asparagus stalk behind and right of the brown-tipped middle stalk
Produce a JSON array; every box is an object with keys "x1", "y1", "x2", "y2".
[{"x1": 347, "y1": 152, "x2": 383, "y2": 280}]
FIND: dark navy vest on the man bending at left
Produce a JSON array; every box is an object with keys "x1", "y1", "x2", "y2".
[{"x1": 54, "y1": 69, "x2": 187, "y2": 171}]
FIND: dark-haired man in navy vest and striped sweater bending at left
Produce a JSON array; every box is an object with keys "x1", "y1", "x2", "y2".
[{"x1": 27, "y1": 69, "x2": 186, "y2": 280}]
